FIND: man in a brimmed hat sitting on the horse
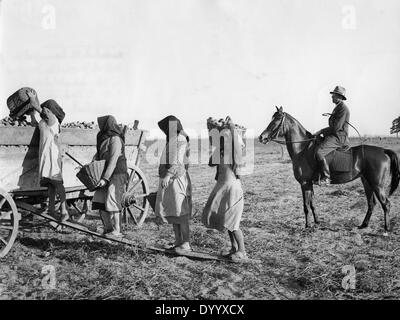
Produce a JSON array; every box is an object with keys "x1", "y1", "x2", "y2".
[{"x1": 315, "y1": 86, "x2": 350, "y2": 185}]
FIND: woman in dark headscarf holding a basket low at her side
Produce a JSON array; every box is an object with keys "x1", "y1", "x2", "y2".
[{"x1": 92, "y1": 115, "x2": 128, "y2": 238}]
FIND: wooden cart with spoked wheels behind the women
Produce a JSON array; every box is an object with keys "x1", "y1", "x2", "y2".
[{"x1": 0, "y1": 127, "x2": 149, "y2": 258}]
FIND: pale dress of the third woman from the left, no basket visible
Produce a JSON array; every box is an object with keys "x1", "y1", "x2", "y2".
[{"x1": 155, "y1": 135, "x2": 192, "y2": 224}]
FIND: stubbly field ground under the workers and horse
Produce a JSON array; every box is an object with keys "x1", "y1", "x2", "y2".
[{"x1": 0, "y1": 138, "x2": 400, "y2": 299}]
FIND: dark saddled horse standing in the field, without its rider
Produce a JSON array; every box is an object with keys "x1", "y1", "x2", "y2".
[{"x1": 259, "y1": 107, "x2": 400, "y2": 236}]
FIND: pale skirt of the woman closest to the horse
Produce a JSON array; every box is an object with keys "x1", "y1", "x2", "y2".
[{"x1": 201, "y1": 164, "x2": 243, "y2": 231}]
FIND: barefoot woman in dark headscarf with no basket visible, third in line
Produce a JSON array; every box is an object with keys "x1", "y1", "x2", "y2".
[{"x1": 155, "y1": 116, "x2": 192, "y2": 253}]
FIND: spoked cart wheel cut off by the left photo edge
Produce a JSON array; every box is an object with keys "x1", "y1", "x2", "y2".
[{"x1": 0, "y1": 189, "x2": 21, "y2": 258}]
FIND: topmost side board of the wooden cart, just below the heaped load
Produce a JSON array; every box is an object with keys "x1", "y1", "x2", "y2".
[{"x1": 0, "y1": 127, "x2": 148, "y2": 147}]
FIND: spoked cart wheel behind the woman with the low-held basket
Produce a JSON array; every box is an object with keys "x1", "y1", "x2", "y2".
[{"x1": 122, "y1": 166, "x2": 149, "y2": 227}]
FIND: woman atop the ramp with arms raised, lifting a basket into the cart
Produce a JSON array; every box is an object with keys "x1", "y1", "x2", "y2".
[{"x1": 26, "y1": 89, "x2": 69, "y2": 222}]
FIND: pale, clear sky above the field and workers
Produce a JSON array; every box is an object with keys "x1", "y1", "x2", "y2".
[{"x1": 0, "y1": 0, "x2": 400, "y2": 136}]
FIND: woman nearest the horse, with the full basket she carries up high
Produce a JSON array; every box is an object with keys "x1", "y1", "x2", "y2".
[{"x1": 202, "y1": 117, "x2": 247, "y2": 261}]
